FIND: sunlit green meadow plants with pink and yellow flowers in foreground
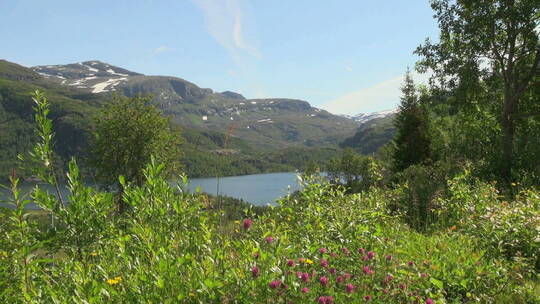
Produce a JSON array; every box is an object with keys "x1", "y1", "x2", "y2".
[{"x1": 0, "y1": 164, "x2": 540, "y2": 303}]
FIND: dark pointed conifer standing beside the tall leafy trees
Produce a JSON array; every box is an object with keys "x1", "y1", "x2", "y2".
[{"x1": 393, "y1": 69, "x2": 432, "y2": 172}]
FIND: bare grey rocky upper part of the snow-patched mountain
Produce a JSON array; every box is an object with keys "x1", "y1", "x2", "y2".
[{"x1": 31, "y1": 61, "x2": 358, "y2": 149}]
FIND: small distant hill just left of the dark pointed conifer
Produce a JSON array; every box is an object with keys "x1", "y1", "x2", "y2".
[{"x1": 340, "y1": 112, "x2": 396, "y2": 154}]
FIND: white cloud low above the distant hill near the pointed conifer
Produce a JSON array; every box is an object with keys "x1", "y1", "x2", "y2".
[{"x1": 320, "y1": 73, "x2": 429, "y2": 115}]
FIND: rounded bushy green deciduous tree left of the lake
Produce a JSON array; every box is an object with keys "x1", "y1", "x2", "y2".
[{"x1": 91, "y1": 96, "x2": 182, "y2": 186}]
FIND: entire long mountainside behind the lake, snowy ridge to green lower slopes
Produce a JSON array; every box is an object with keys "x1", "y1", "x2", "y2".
[{"x1": 0, "y1": 60, "x2": 356, "y2": 179}]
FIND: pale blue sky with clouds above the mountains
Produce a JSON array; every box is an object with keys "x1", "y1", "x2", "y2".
[{"x1": 0, "y1": 0, "x2": 438, "y2": 114}]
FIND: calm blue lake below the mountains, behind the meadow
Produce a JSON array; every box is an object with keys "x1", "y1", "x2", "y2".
[{"x1": 0, "y1": 172, "x2": 301, "y2": 209}]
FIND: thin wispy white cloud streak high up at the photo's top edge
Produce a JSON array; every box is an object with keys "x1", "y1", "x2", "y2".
[{"x1": 192, "y1": 0, "x2": 261, "y2": 63}]
